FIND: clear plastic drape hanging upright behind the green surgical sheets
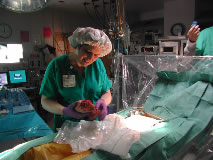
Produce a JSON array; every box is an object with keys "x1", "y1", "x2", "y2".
[{"x1": 112, "y1": 55, "x2": 213, "y2": 111}]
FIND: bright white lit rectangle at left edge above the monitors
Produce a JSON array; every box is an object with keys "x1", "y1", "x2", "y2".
[{"x1": 0, "y1": 44, "x2": 23, "y2": 63}]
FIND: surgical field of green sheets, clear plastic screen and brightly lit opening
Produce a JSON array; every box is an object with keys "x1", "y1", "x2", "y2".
[{"x1": 4, "y1": 56, "x2": 213, "y2": 160}]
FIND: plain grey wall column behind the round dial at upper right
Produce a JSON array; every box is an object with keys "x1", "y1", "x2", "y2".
[{"x1": 164, "y1": 0, "x2": 195, "y2": 36}]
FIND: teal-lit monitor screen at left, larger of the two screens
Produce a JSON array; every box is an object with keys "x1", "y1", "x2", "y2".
[{"x1": 9, "y1": 70, "x2": 27, "y2": 83}]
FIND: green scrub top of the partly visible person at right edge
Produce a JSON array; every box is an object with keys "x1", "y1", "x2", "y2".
[{"x1": 196, "y1": 27, "x2": 213, "y2": 56}]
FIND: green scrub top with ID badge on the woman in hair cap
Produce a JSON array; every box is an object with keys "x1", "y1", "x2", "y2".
[{"x1": 40, "y1": 54, "x2": 112, "y2": 129}]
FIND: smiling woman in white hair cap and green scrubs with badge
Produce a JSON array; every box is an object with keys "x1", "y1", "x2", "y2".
[{"x1": 40, "y1": 27, "x2": 112, "y2": 130}]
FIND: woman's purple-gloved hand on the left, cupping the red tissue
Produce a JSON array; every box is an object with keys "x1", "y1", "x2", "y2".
[{"x1": 63, "y1": 102, "x2": 89, "y2": 119}]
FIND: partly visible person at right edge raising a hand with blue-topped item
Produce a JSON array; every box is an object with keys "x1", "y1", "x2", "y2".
[{"x1": 184, "y1": 25, "x2": 213, "y2": 56}]
